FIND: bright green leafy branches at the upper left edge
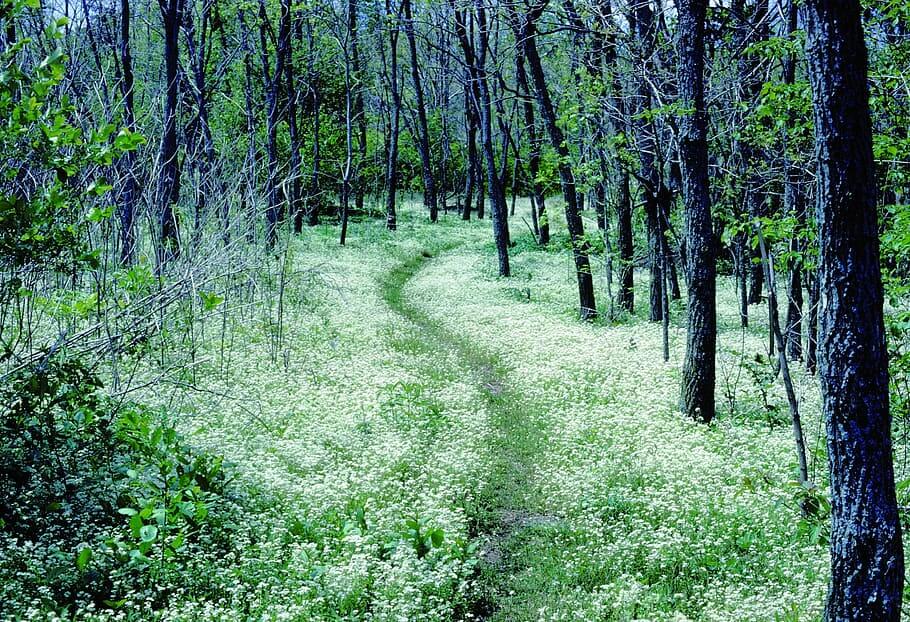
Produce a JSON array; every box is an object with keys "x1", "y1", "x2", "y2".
[{"x1": 0, "y1": 2, "x2": 143, "y2": 294}]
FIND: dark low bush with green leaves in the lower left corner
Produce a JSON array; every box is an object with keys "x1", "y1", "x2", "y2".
[{"x1": 0, "y1": 359, "x2": 242, "y2": 610}]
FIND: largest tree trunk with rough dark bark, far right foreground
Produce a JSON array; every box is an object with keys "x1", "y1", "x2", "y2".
[{"x1": 804, "y1": 0, "x2": 904, "y2": 622}]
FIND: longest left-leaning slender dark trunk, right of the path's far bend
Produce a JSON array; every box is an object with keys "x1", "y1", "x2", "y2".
[{"x1": 512, "y1": 2, "x2": 597, "y2": 320}]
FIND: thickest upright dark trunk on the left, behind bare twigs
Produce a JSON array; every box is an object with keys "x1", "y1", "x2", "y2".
[{"x1": 157, "y1": 0, "x2": 183, "y2": 267}]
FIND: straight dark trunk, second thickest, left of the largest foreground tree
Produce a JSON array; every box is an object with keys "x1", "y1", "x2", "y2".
[{"x1": 677, "y1": 0, "x2": 717, "y2": 422}]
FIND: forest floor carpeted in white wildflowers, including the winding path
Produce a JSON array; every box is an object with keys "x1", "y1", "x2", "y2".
[{"x1": 144, "y1": 200, "x2": 827, "y2": 621}]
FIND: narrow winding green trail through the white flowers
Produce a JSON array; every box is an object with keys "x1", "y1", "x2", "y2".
[{"x1": 380, "y1": 244, "x2": 558, "y2": 620}]
